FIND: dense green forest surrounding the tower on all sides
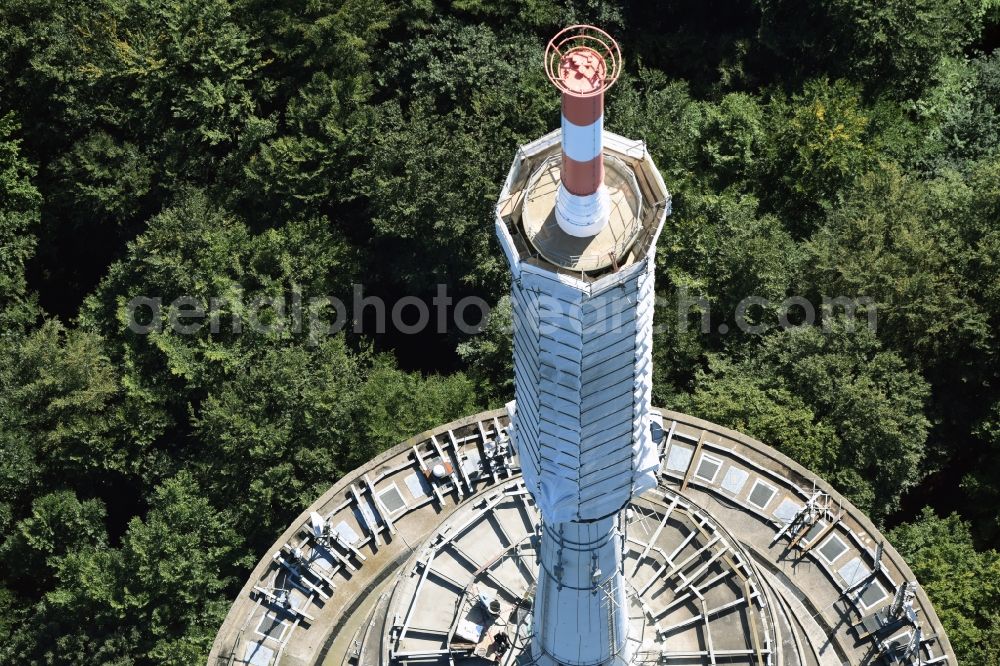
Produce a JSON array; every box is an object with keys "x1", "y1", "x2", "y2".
[{"x1": 0, "y1": 0, "x2": 1000, "y2": 666}]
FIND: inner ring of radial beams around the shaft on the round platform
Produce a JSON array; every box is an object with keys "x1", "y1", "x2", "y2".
[{"x1": 382, "y1": 478, "x2": 780, "y2": 666}]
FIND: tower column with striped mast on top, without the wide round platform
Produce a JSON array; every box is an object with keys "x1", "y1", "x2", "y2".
[{"x1": 496, "y1": 26, "x2": 669, "y2": 666}]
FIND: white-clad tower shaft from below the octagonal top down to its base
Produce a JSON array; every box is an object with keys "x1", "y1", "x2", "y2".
[{"x1": 513, "y1": 256, "x2": 659, "y2": 666}]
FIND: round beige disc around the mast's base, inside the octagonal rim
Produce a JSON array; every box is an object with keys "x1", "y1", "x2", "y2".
[{"x1": 521, "y1": 154, "x2": 643, "y2": 272}]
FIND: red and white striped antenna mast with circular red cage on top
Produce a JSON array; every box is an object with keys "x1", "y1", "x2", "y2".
[{"x1": 545, "y1": 25, "x2": 622, "y2": 237}]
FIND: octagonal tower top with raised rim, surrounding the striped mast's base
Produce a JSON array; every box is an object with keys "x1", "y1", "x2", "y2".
[{"x1": 496, "y1": 130, "x2": 670, "y2": 283}]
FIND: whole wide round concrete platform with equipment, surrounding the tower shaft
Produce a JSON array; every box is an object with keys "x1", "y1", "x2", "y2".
[{"x1": 208, "y1": 410, "x2": 957, "y2": 666}]
